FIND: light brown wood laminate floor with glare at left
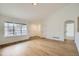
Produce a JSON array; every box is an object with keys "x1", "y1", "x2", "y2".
[{"x1": 0, "y1": 38, "x2": 78, "y2": 56}]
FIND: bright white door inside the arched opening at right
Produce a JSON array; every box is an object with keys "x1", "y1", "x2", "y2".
[{"x1": 65, "y1": 22, "x2": 75, "y2": 40}]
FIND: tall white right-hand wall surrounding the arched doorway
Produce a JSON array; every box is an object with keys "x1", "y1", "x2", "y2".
[{"x1": 43, "y1": 4, "x2": 79, "y2": 49}]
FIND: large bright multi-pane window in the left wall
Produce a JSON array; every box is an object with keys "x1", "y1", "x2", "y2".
[{"x1": 5, "y1": 22, "x2": 27, "y2": 37}]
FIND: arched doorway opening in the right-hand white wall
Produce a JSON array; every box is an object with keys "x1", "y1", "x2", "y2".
[{"x1": 64, "y1": 20, "x2": 75, "y2": 40}]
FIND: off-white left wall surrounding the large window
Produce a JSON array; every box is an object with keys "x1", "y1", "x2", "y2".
[{"x1": 0, "y1": 16, "x2": 29, "y2": 45}]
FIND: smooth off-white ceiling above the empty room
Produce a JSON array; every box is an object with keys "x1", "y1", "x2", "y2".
[{"x1": 0, "y1": 3, "x2": 68, "y2": 20}]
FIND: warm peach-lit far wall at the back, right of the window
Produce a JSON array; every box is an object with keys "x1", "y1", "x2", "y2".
[{"x1": 28, "y1": 20, "x2": 42, "y2": 36}]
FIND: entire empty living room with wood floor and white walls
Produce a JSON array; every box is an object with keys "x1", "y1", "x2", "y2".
[{"x1": 0, "y1": 3, "x2": 79, "y2": 56}]
